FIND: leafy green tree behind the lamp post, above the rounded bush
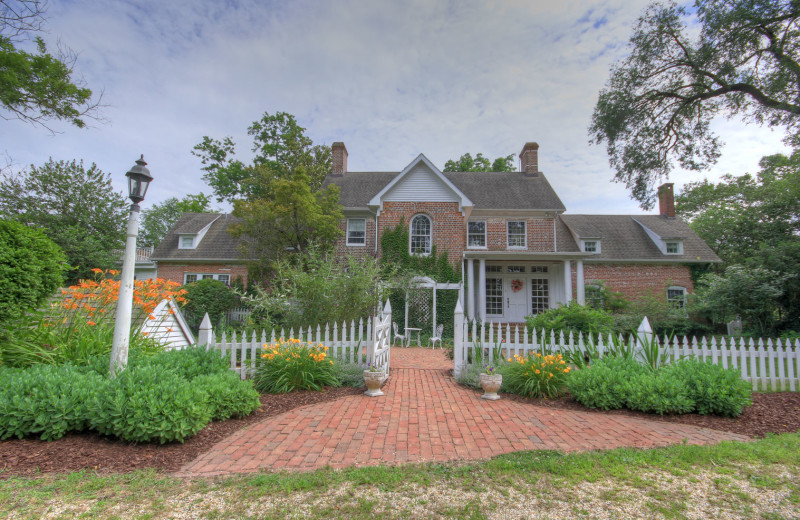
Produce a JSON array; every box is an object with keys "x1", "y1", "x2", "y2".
[{"x1": 0, "y1": 158, "x2": 128, "y2": 283}]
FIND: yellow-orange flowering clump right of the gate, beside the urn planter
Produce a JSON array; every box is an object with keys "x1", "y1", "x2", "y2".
[{"x1": 500, "y1": 352, "x2": 571, "y2": 398}]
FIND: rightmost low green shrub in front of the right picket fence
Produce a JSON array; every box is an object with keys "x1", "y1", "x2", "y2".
[{"x1": 665, "y1": 359, "x2": 752, "y2": 417}]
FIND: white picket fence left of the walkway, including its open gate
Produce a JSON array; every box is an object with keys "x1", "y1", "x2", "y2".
[{"x1": 197, "y1": 301, "x2": 392, "y2": 379}]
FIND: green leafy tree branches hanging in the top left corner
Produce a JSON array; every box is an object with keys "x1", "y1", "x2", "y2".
[{"x1": 0, "y1": 0, "x2": 100, "y2": 129}]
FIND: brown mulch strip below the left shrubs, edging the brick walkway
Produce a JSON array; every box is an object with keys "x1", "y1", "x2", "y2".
[{"x1": 0, "y1": 387, "x2": 364, "y2": 478}]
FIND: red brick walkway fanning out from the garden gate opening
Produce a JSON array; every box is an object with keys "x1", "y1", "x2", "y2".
[{"x1": 179, "y1": 348, "x2": 747, "y2": 476}]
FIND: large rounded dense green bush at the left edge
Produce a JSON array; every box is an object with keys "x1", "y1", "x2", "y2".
[{"x1": 0, "y1": 220, "x2": 68, "y2": 323}]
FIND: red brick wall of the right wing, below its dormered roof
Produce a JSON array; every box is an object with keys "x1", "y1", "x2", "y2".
[{"x1": 572, "y1": 262, "x2": 694, "y2": 300}]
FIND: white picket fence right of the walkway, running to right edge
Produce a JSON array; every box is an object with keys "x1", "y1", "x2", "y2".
[{"x1": 453, "y1": 305, "x2": 800, "y2": 392}]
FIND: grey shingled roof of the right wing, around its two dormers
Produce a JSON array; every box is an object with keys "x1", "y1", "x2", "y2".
[{"x1": 561, "y1": 215, "x2": 720, "y2": 263}]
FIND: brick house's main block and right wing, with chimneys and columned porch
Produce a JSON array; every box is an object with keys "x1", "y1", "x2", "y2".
[{"x1": 325, "y1": 142, "x2": 720, "y2": 322}]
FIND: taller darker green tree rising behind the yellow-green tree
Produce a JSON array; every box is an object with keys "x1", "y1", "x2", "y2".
[{"x1": 192, "y1": 112, "x2": 331, "y2": 202}]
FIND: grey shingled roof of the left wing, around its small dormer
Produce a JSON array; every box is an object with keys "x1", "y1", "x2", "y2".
[{"x1": 150, "y1": 213, "x2": 242, "y2": 262}]
